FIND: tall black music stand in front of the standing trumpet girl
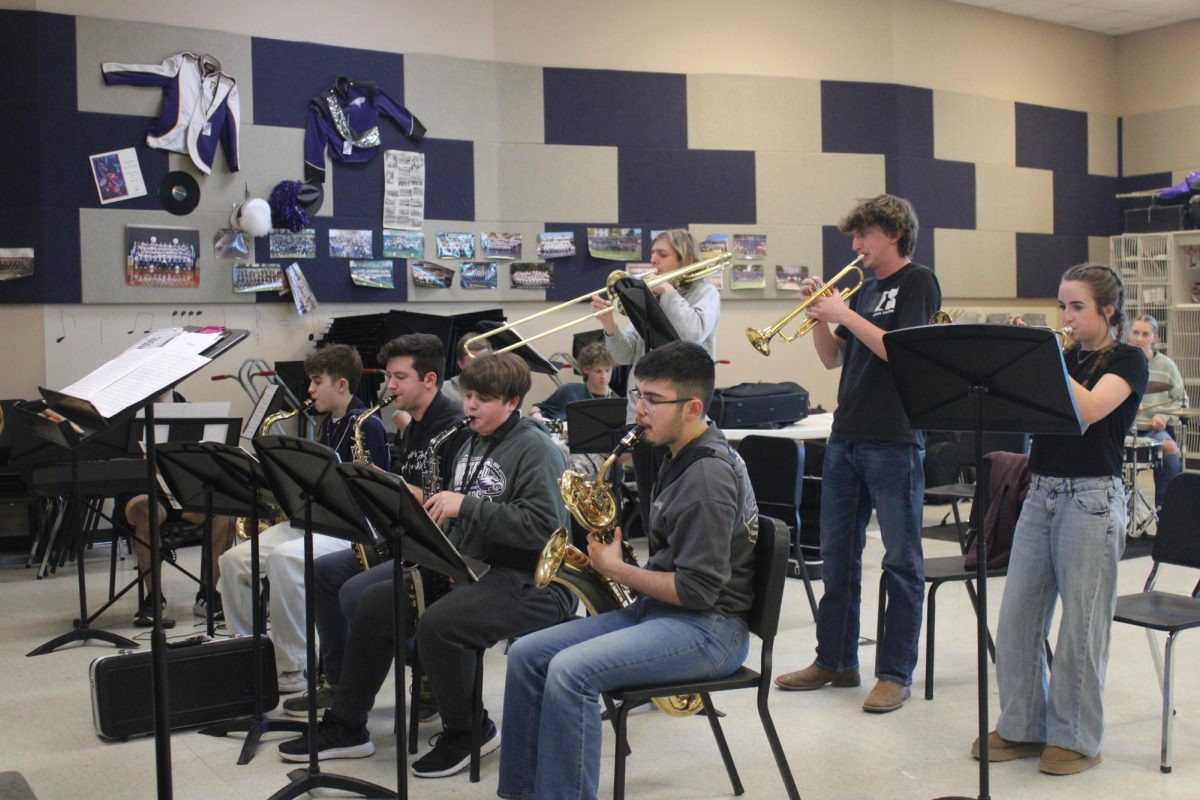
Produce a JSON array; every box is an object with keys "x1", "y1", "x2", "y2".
[{"x1": 883, "y1": 325, "x2": 1086, "y2": 800}]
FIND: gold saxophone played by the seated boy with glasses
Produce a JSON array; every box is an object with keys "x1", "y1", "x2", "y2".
[{"x1": 534, "y1": 425, "x2": 703, "y2": 716}]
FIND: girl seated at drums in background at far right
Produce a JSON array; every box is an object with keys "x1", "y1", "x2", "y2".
[{"x1": 1129, "y1": 314, "x2": 1188, "y2": 507}]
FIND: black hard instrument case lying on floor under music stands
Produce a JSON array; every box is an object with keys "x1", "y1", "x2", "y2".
[{"x1": 90, "y1": 636, "x2": 280, "y2": 740}]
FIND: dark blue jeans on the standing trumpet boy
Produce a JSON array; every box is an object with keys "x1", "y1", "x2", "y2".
[{"x1": 816, "y1": 437, "x2": 925, "y2": 686}]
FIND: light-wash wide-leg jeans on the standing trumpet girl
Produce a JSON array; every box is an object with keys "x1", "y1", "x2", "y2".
[{"x1": 996, "y1": 475, "x2": 1126, "y2": 757}]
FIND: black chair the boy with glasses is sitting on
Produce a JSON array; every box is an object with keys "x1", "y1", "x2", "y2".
[{"x1": 604, "y1": 517, "x2": 800, "y2": 800}]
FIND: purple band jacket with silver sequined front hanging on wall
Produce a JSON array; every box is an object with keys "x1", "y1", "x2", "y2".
[{"x1": 304, "y1": 78, "x2": 425, "y2": 184}]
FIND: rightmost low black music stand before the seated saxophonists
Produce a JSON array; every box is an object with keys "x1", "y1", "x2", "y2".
[{"x1": 337, "y1": 464, "x2": 487, "y2": 800}]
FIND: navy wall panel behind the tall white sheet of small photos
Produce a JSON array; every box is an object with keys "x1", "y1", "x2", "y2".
[{"x1": 326, "y1": 134, "x2": 475, "y2": 221}]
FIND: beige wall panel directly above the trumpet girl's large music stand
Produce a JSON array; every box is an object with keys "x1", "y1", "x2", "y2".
[{"x1": 934, "y1": 228, "x2": 1016, "y2": 299}]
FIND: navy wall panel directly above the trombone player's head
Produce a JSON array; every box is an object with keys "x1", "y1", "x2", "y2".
[{"x1": 617, "y1": 148, "x2": 758, "y2": 224}]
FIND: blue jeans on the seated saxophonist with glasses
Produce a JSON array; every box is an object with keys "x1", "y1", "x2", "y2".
[{"x1": 497, "y1": 597, "x2": 750, "y2": 800}]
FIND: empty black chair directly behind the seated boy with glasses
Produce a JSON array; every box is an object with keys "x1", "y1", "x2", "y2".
[{"x1": 738, "y1": 434, "x2": 821, "y2": 622}]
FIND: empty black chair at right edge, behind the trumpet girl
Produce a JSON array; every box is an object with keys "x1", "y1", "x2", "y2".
[{"x1": 1112, "y1": 473, "x2": 1200, "y2": 772}]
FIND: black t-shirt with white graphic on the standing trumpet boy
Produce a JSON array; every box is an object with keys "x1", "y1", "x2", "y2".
[{"x1": 833, "y1": 264, "x2": 942, "y2": 444}]
